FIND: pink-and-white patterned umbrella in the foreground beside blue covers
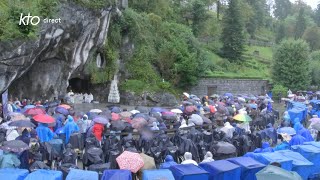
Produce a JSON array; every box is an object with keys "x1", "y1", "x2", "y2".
[{"x1": 116, "y1": 151, "x2": 144, "y2": 173}]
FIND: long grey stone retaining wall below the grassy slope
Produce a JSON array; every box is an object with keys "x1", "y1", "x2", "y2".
[{"x1": 191, "y1": 78, "x2": 269, "y2": 97}]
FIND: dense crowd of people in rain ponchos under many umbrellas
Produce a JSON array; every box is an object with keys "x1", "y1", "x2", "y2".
[{"x1": 0, "y1": 93, "x2": 318, "y2": 177}]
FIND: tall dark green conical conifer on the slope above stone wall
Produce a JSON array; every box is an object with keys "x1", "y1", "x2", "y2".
[{"x1": 221, "y1": 0, "x2": 245, "y2": 61}]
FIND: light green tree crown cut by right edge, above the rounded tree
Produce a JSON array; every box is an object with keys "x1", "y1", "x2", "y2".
[{"x1": 302, "y1": 26, "x2": 320, "y2": 51}]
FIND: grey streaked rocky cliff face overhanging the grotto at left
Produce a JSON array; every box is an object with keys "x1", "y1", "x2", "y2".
[{"x1": 0, "y1": 4, "x2": 111, "y2": 99}]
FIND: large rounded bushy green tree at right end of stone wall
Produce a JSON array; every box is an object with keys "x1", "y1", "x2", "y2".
[{"x1": 272, "y1": 39, "x2": 310, "y2": 90}]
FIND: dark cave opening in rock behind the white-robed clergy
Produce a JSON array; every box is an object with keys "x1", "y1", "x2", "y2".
[{"x1": 68, "y1": 78, "x2": 91, "y2": 94}]
